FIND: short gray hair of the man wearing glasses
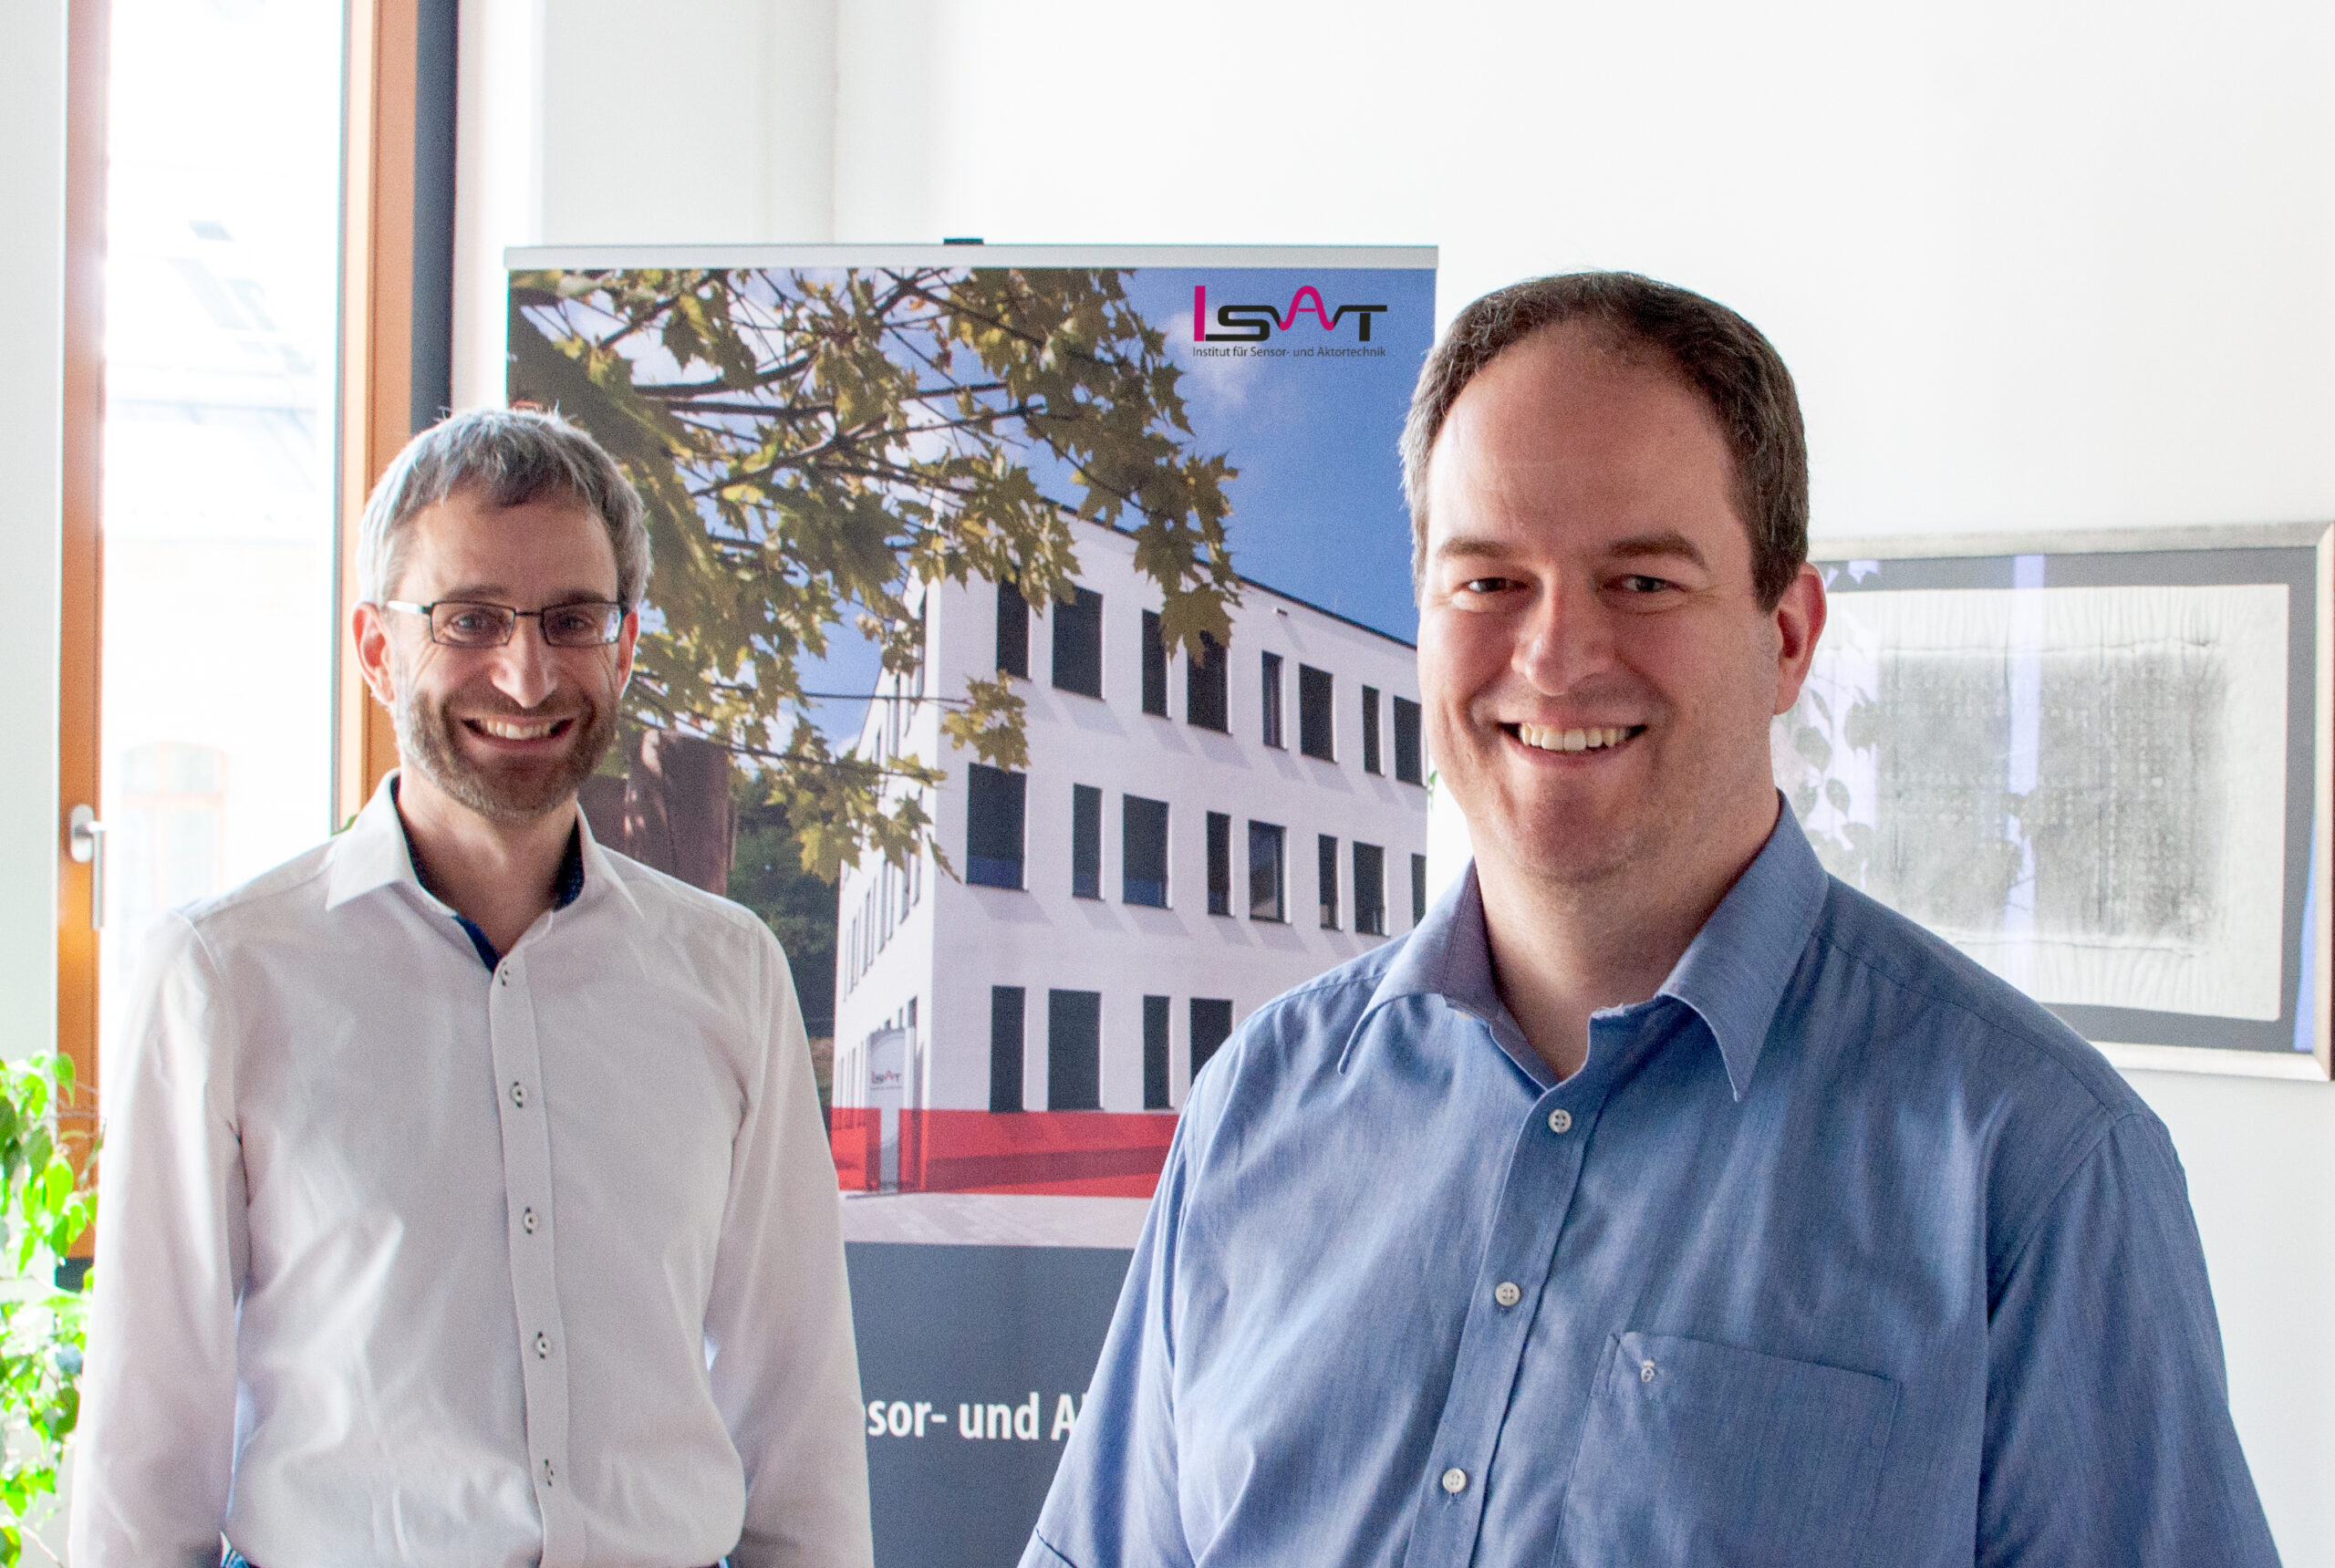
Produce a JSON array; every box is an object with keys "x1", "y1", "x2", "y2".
[{"x1": 358, "y1": 409, "x2": 649, "y2": 610}]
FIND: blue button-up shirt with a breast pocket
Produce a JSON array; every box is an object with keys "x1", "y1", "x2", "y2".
[{"x1": 1022, "y1": 808, "x2": 2277, "y2": 1568}]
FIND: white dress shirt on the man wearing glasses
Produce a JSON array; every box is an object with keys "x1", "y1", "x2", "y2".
[{"x1": 72, "y1": 783, "x2": 871, "y2": 1568}]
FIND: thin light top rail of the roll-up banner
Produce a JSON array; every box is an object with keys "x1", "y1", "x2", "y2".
[{"x1": 502, "y1": 243, "x2": 1436, "y2": 271}]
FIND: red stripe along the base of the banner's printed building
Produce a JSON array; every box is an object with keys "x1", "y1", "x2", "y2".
[{"x1": 829, "y1": 1107, "x2": 1177, "y2": 1199}]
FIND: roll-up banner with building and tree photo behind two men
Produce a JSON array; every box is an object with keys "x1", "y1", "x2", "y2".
[{"x1": 509, "y1": 245, "x2": 1436, "y2": 1568}]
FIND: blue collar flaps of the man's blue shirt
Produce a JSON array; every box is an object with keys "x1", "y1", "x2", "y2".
[{"x1": 1347, "y1": 802, "x2": 1826, "y2": 1101}]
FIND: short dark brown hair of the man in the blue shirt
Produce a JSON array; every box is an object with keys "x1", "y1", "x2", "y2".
[{"x1": 1404, "y1": 271, "x2": 1807, "y2": 610}]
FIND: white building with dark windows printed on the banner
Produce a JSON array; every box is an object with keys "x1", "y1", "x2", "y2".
[{"x1": 834, "y1": 525, "x2": 1427, "y2": 1112}]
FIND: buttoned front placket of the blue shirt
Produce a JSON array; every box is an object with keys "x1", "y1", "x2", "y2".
[{"x1": 1404, "y1": 1010, "x2": 1630, "y2": 1568}]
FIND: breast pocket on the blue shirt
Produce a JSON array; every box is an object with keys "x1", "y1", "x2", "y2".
[{"x1": 1555, "y1": 1334, "x2": 1898, "y2": 1568}]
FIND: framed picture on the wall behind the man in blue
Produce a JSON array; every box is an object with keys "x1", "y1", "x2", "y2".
[{"x1": 1775, "y1": 524, "x2": 2335, "y2": 1080}]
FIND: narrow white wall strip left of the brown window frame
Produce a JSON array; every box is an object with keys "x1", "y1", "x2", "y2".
[{"x1": 0, "y1": 0, "x2": 66, "y2": 1056}]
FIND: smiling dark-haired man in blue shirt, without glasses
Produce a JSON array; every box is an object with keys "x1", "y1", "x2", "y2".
[{"x1": 1022, "y1": 274, "x2": 2277, "y2": 1568}]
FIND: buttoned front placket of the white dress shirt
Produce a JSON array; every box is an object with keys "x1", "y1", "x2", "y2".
[{"x1": 485, "y1": 932, "x2": 584, "y2": 1568}]
